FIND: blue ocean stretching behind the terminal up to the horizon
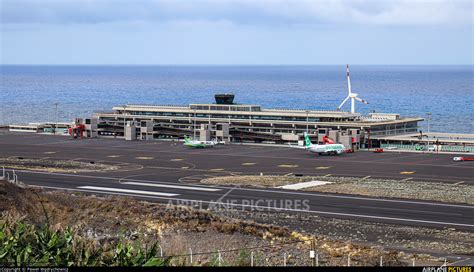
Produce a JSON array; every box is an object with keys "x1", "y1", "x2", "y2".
[{"x1": 0, "y1": 65, "x2": 474, "y2": 133}]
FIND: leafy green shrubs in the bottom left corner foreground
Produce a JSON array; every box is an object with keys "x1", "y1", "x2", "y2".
[{"x1": 0, "y1": 221, "x2": 168, "y2": 267}]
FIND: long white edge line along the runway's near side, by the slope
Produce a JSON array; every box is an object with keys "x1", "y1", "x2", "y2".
[{"x1": 34, "y1": 186, "x2": 474, "y2": 228}]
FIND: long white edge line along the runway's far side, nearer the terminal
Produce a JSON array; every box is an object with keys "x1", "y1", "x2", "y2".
[{"x1": 14, "y1": 169, "x2": 474, "y2": 209}]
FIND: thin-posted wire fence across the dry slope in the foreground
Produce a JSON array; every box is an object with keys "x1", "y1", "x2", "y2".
[{"x1": 0, "y1": 242, "x2": 456, "y2": 267}]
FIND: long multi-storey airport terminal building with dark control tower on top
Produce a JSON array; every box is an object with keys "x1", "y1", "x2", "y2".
[{"x1": 85, "y1": 94, "x2": 423, "y2": 149}]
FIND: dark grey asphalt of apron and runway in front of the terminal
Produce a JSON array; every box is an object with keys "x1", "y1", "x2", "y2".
[{"x1": 0, "y1": 133, "x2": 474, "y2": 231}]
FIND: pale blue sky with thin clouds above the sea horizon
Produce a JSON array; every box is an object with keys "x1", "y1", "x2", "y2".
[{"x1": 0, "y1": 0, "x2": 474, "y2": 65}]
